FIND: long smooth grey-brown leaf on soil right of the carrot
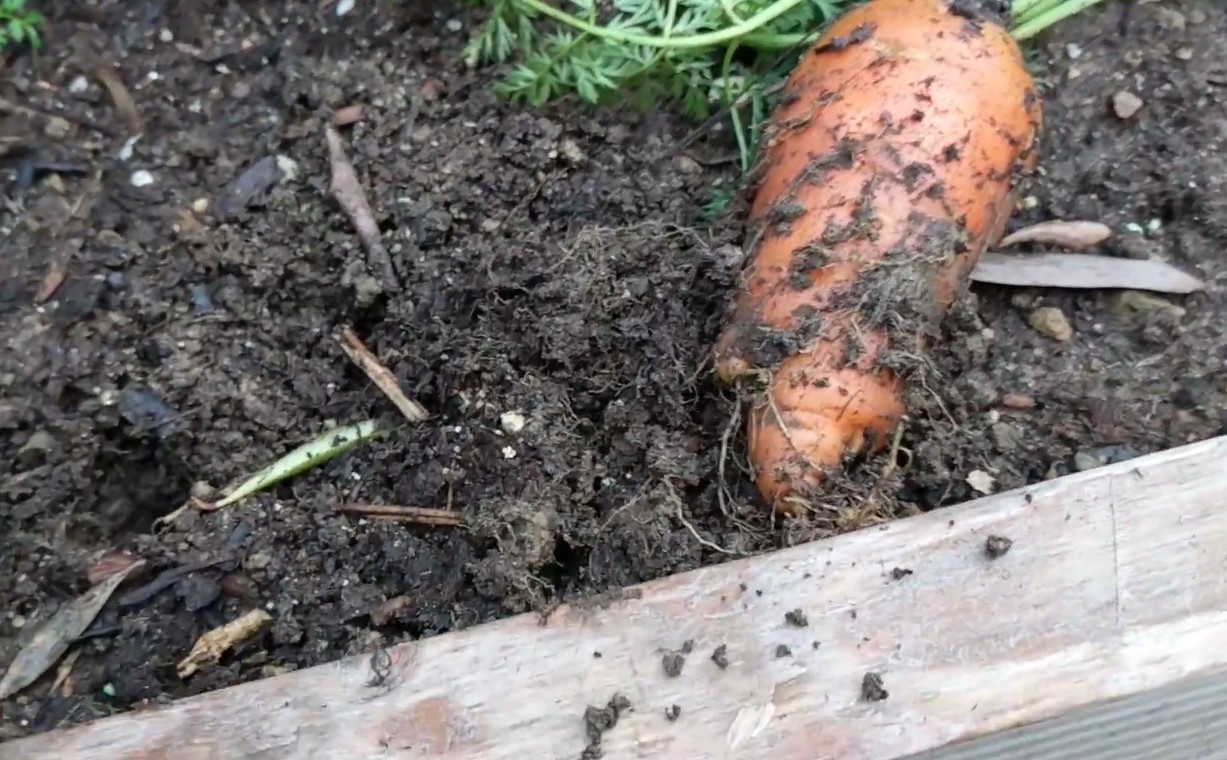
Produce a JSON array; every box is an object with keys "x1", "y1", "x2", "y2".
[{"x1": 972, "y1": 252, "x2": 1206, "y2": 293}]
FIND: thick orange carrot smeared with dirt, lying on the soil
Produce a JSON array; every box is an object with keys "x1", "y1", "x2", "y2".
[{"x1": 715, "y1": 0, "x2": 1042, "y2": 513}]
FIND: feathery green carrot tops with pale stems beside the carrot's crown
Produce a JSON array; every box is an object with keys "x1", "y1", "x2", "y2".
[{"x1": 464, "y1": 0, "x2": 1103, "y2": 172}]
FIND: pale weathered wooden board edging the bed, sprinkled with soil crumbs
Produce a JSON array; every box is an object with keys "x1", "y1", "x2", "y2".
[{"x1": 0, "y1": 438, "x2": 1227, "y2": 760}]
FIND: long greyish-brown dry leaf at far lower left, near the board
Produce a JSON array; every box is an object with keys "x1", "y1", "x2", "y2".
[{"x1": 0, "y1": 561, "x2": 145, "y2": 700}]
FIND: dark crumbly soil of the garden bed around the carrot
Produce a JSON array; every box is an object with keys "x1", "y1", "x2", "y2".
[{"x1": 0, "y1": 0, "x2": 1227, "y2": 740}]
